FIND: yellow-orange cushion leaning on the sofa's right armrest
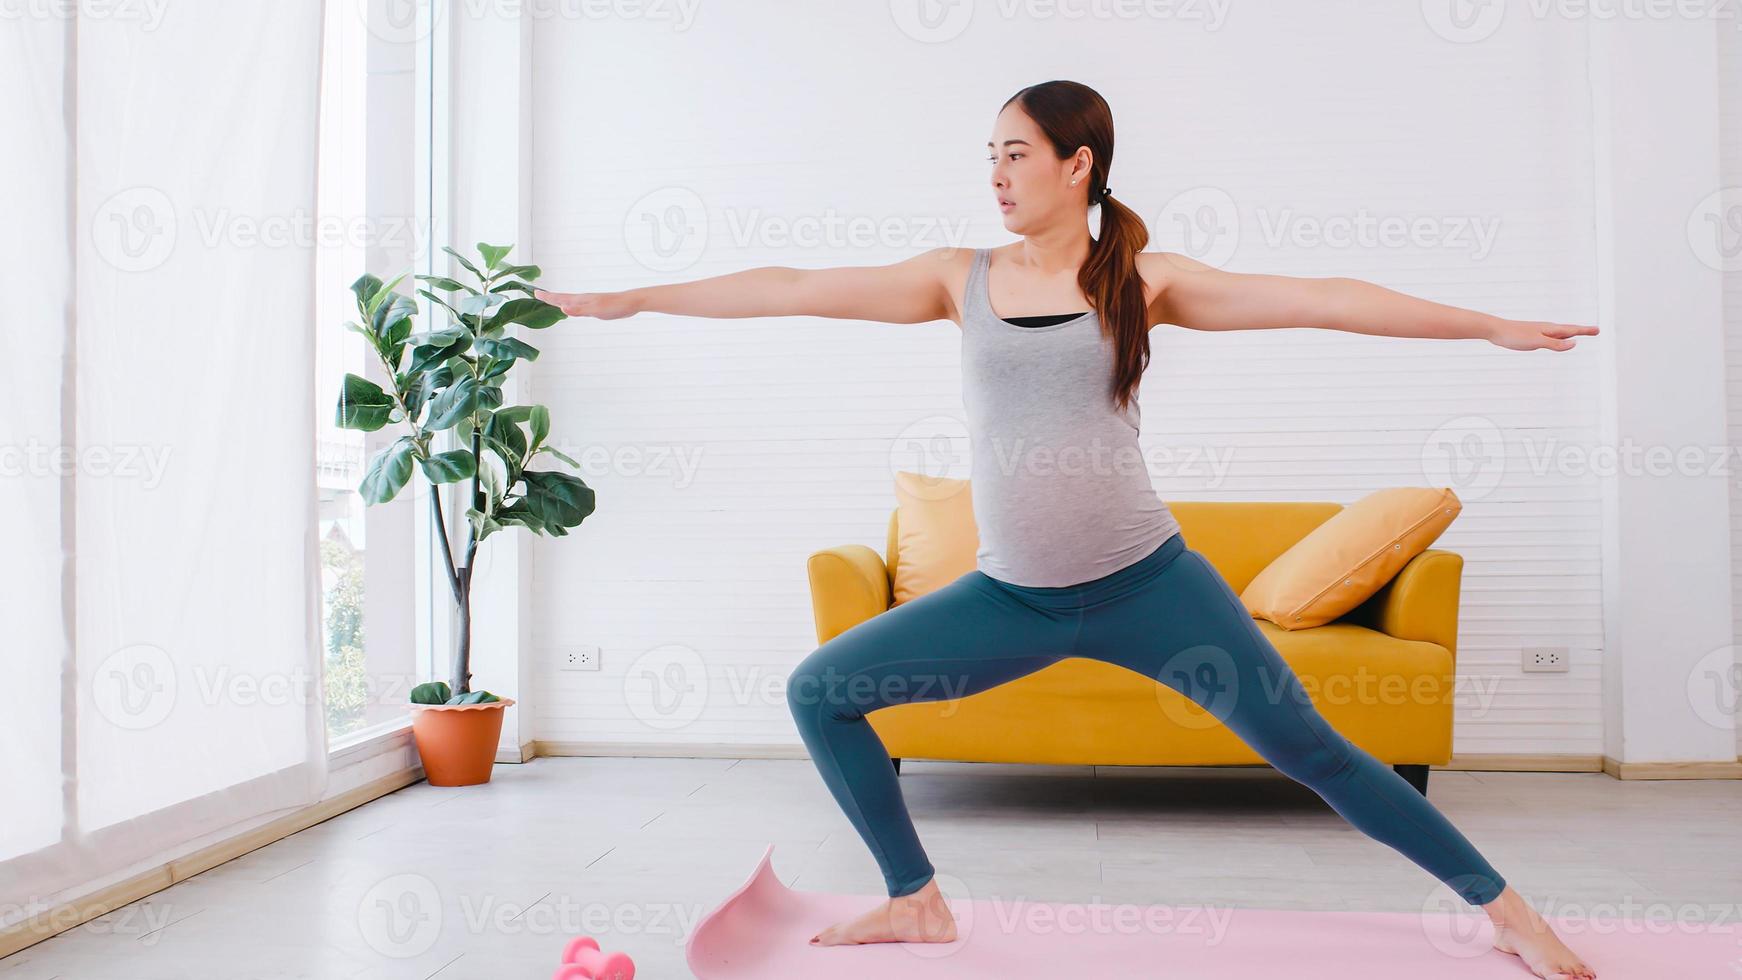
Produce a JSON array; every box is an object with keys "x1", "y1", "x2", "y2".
[{"x1": 1240, "y1": 487, "x2": 1463, "y2": 630}]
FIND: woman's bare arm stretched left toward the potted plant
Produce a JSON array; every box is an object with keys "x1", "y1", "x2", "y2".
[{"x1": 535, "y1": 249, "x2": 956, "y2": 324}]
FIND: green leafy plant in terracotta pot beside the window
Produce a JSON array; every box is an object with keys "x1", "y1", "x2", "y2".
[{"x1": 336, "y1": 242, "x2": 594, "y2": 787}]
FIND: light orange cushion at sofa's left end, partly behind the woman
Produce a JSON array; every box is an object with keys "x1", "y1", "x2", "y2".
[{"x1": 890, "y1": 470, "x2": 979, "y2": 606}]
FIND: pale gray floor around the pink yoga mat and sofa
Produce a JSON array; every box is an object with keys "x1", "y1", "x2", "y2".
[{"x1": 0, "y1": 759, "x2": 1742, "y2": 980}]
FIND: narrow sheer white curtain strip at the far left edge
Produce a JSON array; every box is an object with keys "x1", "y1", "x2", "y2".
[{"x1": 0, "y1": 3, "x2": 73, "y2": 873}]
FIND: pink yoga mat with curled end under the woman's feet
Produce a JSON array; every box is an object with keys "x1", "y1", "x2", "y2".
[{"x1": 686, "y1": 846, "x2": 1742, "y2": 980}]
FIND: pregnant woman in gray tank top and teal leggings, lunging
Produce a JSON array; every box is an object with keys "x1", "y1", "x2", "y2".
[{"x1": 538, "y1": 82, "x2": 1597, "y2": 978}]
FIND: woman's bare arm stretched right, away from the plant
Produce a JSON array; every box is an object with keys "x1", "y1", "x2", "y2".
[{"x1": 1143, "y1": 252, "x2": 1597, "y2": 350}]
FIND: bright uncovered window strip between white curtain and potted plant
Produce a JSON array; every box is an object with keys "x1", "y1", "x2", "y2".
[{"x1": 314, "y1": 3, "x2": 441, "y2": 745}]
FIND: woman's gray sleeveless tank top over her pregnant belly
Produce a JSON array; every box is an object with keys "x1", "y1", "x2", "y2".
[{"x1": 962, "y1": 249, "x2": 1179, "y2": 588}]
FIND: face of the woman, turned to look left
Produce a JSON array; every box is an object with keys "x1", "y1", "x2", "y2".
[{"x1": 986, "y1": 103, "x2": 1089, "y2": 235}]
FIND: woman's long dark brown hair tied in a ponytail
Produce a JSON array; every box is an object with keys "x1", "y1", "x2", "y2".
[{"x1": 1003, "y1": 80, "x2": 1150, "y2": 409}]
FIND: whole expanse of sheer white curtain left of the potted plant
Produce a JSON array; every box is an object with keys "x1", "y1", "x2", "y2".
[{"x1": 0, "y1": 0, "x2": 326, "y2": 909}]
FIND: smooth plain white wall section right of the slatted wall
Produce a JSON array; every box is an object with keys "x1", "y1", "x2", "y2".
[{"x1": 1590, "y1": 11, "x2": 1735, "y2": 775}]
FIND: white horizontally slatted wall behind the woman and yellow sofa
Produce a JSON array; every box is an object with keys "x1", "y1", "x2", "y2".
[{"x1": 531, "y1": 0, "x2": 1601, "y2": 754}]
